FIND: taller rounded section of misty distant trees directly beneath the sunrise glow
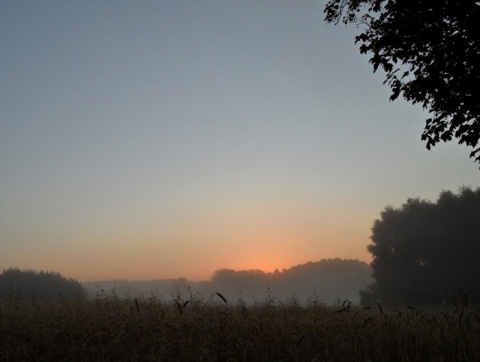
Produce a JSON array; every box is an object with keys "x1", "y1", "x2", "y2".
[{"x1": 207, "y1": 258, "x2": 372, "y2": 304}]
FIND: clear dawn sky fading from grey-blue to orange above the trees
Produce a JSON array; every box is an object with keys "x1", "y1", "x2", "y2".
[{"x1": 0, "y1": 0, "x2": 480, "y2": 281}]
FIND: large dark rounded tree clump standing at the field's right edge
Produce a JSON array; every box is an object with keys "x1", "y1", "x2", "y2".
[{"x1": 361, "y1": 187, "x2": 480, "y2": 304}]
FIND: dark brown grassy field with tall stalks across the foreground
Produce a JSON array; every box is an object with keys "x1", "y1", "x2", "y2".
[{"x1": 0, "y1": 294, "x2": 480, "y2": 361}]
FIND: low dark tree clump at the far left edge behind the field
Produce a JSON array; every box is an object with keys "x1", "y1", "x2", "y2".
[{"x1": 0, "y1": 268, "x2": 86, "y2": 299}]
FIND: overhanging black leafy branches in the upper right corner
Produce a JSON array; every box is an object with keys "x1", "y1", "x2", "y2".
[{"x1": 325, "y1": 0, "x2": 480, "y2": 163}]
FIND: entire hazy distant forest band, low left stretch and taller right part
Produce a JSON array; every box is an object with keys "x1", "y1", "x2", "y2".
[{"x1": 83, "y1": 258, "x2": 372, "y2": 304}]
